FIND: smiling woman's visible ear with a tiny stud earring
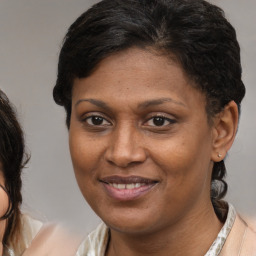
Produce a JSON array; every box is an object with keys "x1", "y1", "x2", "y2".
[{"x1": 211, "y1": 101, "x2": 239, "y2": 162}]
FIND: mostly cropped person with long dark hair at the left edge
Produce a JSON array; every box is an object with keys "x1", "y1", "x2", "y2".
[{"x1": 0, "y1": 90, "x2": 81, "y2": 256}]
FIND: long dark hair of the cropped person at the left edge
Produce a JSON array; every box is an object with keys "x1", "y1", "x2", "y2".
[{"x1": 0, "y1": 90, "x2": 27, "y2": 246}]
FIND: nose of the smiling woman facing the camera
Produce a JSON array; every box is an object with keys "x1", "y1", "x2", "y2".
[{"x1": 105, "y1": 124, "x2": 147, "y2": 168}]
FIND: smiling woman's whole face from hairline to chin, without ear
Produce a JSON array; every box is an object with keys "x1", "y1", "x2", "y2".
[{"x1": 69, "y1": 48, "x2": 216, "y2": 233}]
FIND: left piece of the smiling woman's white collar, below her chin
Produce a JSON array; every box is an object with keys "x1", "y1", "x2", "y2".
[{"x1": 76, "y1": 223, "x2": 109, "y2": 256}]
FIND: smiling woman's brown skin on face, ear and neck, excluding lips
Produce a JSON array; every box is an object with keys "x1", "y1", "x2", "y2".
[{"x1": 69, "y1": 48, "x2": 238, "y2": 256}]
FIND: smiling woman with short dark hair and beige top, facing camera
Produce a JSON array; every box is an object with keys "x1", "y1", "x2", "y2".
[{"x1": 53, "y1": 0, "x2": 256, "y2": 256}]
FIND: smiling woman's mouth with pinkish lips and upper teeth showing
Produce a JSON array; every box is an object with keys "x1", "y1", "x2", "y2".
[{"x1": 100, "y1": 175, "x2": 158, "y2": 201}]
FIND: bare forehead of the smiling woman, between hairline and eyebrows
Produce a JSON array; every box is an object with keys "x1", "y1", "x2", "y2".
[{"x1": 72, "y1": 48, "x2": 204, "y2": 111}]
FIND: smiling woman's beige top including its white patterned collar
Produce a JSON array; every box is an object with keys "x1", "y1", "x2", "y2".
[{"x1": 76, "y1": 204, "x2": 256, "y2": 256}]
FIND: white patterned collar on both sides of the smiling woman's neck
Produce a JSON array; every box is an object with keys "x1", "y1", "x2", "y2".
[{"x1": 76, "y1": 204, "x2": 236, "y2": 256}]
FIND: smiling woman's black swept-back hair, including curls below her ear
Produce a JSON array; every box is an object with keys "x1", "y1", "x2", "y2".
[{"x1": 53, "y1": 0, "x2": 245, "y2": 221}]
